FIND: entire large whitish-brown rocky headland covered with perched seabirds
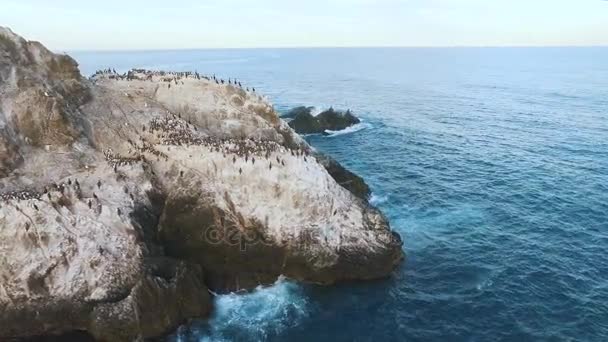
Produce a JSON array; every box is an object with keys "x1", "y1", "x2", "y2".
[{"x1": 0, "y1": 28, "x2": 403, "y2": 341}]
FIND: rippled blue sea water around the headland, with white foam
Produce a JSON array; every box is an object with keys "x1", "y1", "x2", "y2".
[{"x1": 73, "y1": 48, "x2": 608, "y2": 342}]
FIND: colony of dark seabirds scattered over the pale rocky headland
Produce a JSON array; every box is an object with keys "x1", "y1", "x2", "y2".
[{"x1": 0, "y1": 69, "x2": 310, "y2": 218}]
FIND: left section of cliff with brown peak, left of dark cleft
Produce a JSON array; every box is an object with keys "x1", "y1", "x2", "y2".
[{"x1": 0, "y1": 28, "x2": 210, "y2": 341}]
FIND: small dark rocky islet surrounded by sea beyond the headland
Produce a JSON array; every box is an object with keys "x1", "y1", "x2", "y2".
[{"x1": 283, "y1": 107, "x2": 361, "y2": 134}]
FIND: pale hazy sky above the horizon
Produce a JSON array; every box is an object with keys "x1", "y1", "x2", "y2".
[{"x1": 0, "y1": 0, "x2": 608, "y2": 50}]
